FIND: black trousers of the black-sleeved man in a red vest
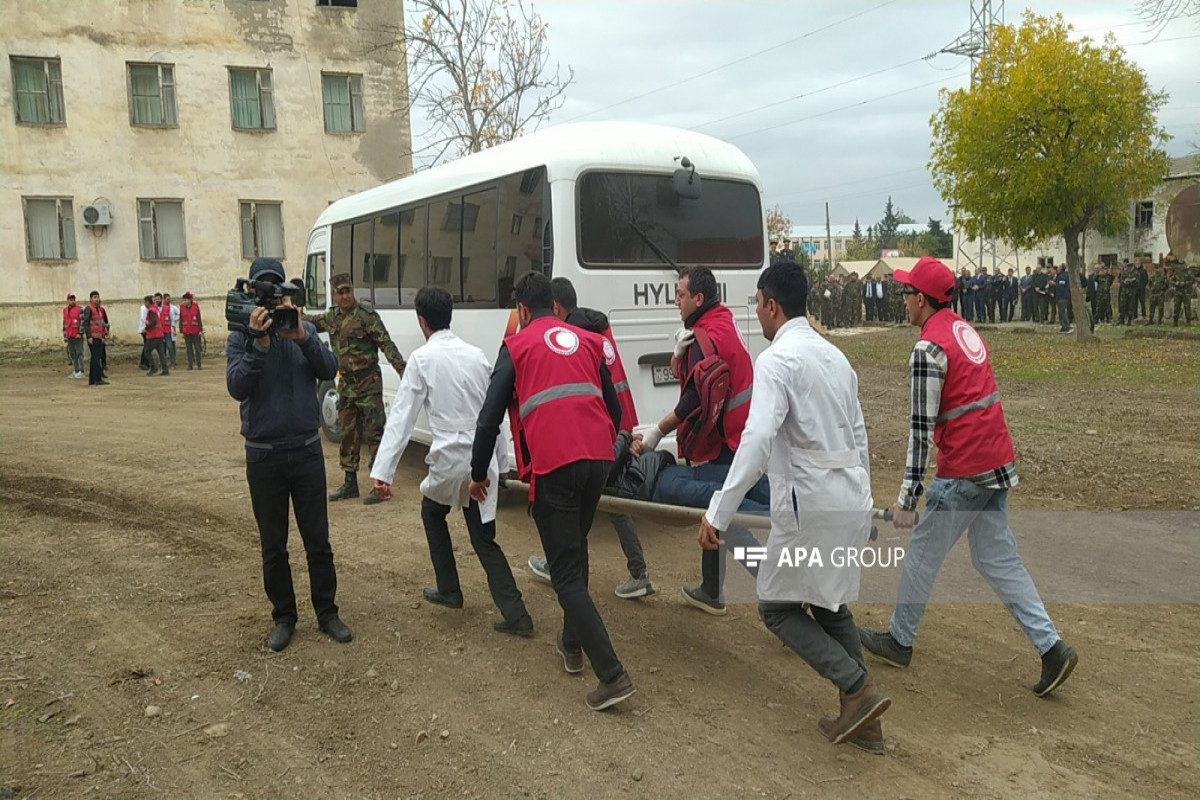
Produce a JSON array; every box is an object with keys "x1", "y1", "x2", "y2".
[{"x1": 533, "y1": 461, "x2": 625, "y2": 682}]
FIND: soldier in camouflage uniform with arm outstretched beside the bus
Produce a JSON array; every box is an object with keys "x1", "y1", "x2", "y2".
[{"x1": 305, "y1": 272, "x2": 404, "y2": 505}]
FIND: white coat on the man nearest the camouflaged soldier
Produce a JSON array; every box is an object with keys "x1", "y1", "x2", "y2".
[{"x1": 371, "y1": 330, "x2": 508, "y2": 522}]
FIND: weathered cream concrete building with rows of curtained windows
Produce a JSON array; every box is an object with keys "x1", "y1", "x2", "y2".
[{"x1": 0, "y1": 0, "x2": 413, "y2": 341}]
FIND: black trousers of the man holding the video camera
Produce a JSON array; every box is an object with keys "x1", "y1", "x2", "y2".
[{"x1": 246, "y1": 441, "x2": 337, "y2": 624}]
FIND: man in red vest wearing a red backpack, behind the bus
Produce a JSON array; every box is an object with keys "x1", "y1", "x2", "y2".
[{"x1": 641, "y1": 266, "x2": 770, "y2": 616}]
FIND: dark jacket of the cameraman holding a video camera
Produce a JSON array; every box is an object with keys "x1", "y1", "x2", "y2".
[{"x1": 226, "y1": 323, "x2": 337, "y2": 450}]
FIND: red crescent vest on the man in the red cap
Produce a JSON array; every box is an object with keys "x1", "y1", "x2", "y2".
[{"x1": 920, "y1": 308, "x2": 1015, "y2": 477}]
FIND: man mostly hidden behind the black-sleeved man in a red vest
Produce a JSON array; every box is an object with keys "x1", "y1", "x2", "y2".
[{"x1": 529, "y1": 277, "x2": 654, "y2": 600}]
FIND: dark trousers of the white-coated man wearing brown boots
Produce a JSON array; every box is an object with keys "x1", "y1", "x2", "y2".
[{"x1": 758, "y1": 603, "x2": 866, "y2": 692}]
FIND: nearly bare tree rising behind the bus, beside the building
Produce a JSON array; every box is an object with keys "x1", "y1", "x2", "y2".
[{"x1": 369, "y1": 0, "x2": 575, "y2": 164}]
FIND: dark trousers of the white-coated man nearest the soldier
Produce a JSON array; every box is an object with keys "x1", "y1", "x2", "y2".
[{"x1": 421, "y1": 498, "x2": 529, "y2": 622}]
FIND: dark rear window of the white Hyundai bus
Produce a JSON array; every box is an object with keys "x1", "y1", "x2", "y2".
[{"x1": 578, "y1": 173, "x2": 764, "y2": 269}]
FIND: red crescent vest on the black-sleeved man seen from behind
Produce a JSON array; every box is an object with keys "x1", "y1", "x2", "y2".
[{"x1": 505, "y1": 315, "x2": 617, "y2": 475}]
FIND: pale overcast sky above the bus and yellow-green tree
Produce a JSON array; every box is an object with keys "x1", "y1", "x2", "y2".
[{"x1": 414, "y1": 0, "x2": 1200, "y2": 229}]
